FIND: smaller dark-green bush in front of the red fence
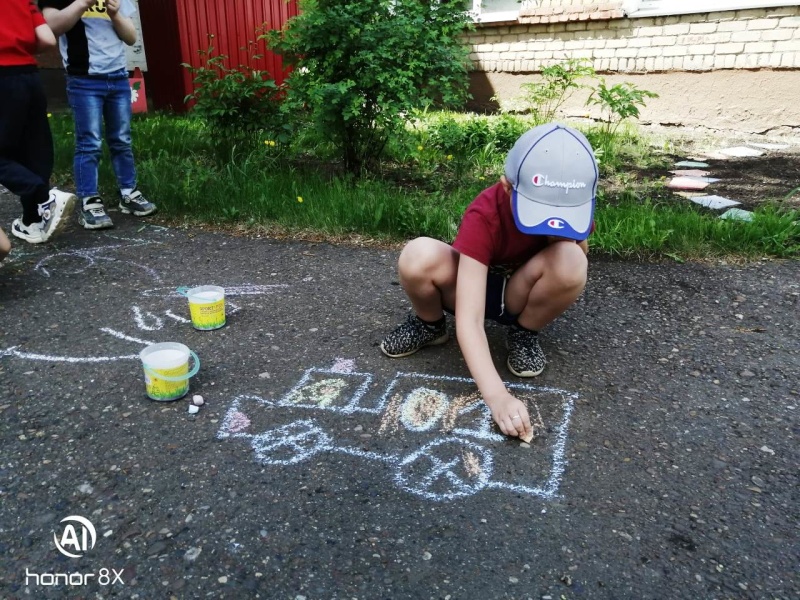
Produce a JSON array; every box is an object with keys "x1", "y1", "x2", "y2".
[{"x1": 182, "y1": 35, "x2": 289, "y2": 141}]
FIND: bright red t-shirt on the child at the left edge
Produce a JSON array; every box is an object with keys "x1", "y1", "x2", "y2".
[{"x1": 0, "y1": 0, "x2": 45, "y2": 67}]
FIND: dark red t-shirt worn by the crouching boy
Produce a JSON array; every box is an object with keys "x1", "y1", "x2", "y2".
[{"x1": 453, "y1": 182, "x2": 547, "y2": 267}]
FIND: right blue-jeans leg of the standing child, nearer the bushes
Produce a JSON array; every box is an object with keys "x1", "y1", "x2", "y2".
[{"x1": 103, "y1": 76, "x2": 136, "y2": 193}]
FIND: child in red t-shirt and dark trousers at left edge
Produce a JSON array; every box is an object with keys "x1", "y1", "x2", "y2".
[{"x1": 0, "y1": 0, "x2": 75, "y2": 248}]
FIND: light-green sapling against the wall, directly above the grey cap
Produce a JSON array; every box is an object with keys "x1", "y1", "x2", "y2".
[{"x1": 520, "y1": 58, "x2": 597, "y2": 124}]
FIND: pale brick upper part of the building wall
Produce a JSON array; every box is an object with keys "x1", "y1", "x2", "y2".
[{"x1": 469, "y1": 0, "x2": 800, "y2": 73}]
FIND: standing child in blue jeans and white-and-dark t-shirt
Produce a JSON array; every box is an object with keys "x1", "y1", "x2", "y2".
[{"x1": 39, "y1": 0, "x2": 156, "y2": 229}]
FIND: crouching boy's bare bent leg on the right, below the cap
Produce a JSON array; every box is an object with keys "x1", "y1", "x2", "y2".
[{"x1": 506, "y1": 241, "x2": 588, "y2": 331}]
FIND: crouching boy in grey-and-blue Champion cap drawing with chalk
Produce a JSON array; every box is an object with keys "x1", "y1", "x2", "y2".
[{"x1": 381, "y1": 123, "x2": 598, "y2": 437}]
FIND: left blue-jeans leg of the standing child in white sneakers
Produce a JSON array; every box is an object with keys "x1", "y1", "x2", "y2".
[{"x1": 67, "y1": 77, "x2": 108, "y2": 199}]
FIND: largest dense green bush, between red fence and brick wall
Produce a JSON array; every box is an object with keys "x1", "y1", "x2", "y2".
[{"x1": 263, "y1": 0, "x2": 470, "y2": 174}]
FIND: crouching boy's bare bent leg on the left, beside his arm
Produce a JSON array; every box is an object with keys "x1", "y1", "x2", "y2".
[{"x1": 397, "y1": 237, "x2": 458, "y2": 322}]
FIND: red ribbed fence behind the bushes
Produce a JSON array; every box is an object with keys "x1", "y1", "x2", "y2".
[{"x1": 139, "y1": 0, "x2": 297, "y2": 111}]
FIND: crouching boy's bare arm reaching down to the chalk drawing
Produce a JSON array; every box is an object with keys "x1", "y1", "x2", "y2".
[{"x1": 456, "y1": 254, "x2": 532, "y2": 436}]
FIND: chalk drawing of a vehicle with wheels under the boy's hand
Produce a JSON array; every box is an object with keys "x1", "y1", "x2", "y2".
[{"x1": 217, "y1": 359, "x2": 577, "y2": 501}]
